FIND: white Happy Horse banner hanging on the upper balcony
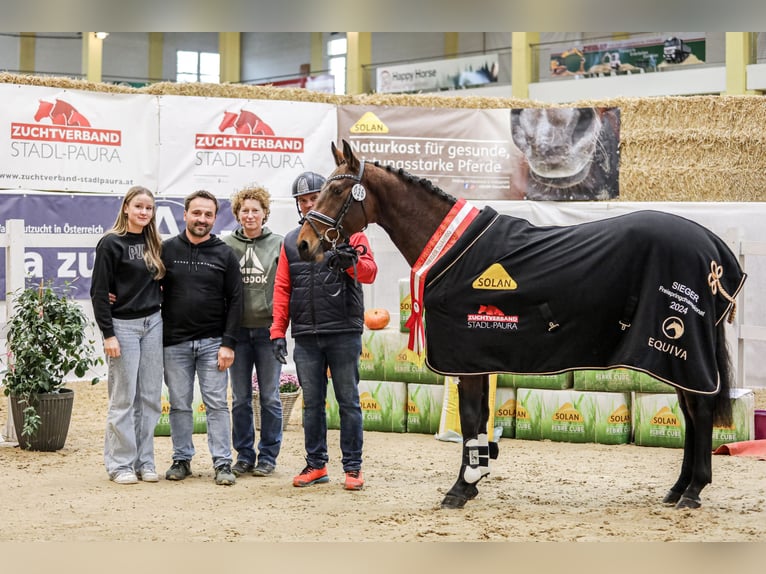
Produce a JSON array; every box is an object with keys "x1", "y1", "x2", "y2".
[{"x1": 375, "y1": 54, "x2": 499, "y2": 94}]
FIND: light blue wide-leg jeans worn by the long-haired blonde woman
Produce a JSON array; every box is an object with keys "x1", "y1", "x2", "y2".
[{"x1": 104, "y1": 311, "x2": 162, "y2": 478}]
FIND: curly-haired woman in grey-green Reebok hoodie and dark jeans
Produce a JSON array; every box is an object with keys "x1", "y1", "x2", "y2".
[{"x1": 223, "y1": 186, "x2": 282, "y2": 476}]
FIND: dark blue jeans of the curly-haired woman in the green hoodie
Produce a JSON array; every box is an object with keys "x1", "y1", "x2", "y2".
[{"x1": 229, "y1": 327, "x2": 282, "y2": 466}]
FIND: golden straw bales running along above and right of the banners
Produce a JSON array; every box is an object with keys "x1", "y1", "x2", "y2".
[{"x1": 0, "y1": 73, "x2": 766, "y2": 201}]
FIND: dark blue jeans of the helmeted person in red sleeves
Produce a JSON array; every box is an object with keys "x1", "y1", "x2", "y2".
[{"x1": 293, "y1": 333, "x2": 363, "y2": 471}]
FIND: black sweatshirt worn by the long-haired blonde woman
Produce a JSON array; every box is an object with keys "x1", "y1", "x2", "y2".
[{"x1": 90, "y1": 233, "x2": 161, "y2": 339}]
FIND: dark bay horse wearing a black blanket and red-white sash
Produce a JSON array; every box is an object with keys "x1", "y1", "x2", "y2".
[{"x1": 297, "y1": 140, "x2": 746, "y2": 509}]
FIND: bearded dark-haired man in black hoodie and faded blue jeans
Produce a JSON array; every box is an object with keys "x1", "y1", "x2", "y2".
[{"x1": 162, "y1": 190, "x2": 243, "y2": 485}]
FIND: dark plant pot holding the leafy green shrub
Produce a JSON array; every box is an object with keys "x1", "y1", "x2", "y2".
[{"x1": 10, "y1": 389, "x2": 74, "y2": 452}]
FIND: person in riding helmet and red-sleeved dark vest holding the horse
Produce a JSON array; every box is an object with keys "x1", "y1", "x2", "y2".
[{"x1": 271, "y1": 172, "x2": 378, "y2": 490}]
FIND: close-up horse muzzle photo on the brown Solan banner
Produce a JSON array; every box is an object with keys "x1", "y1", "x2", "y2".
[{"x1": 509, "y1": 108, "x2": 620, "y2": 201}]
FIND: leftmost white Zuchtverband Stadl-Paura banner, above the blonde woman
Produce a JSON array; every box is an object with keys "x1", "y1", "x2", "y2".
[{"x1": 0, "y1": 84, "x2": 159, "y2": 194}]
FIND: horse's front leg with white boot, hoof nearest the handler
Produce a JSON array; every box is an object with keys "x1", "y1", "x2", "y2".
[{"x1": 441, "y1": 375, "x2": 489, "y2": 508}]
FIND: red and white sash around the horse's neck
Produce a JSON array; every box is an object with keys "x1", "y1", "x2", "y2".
[{"x1": 406, "y1": 198, "x2": 479, "y2": 355}]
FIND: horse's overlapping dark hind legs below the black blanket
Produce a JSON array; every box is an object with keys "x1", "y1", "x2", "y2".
[{"x1": 662, "y1": 390, "x2": 715, "y2": 508}]
